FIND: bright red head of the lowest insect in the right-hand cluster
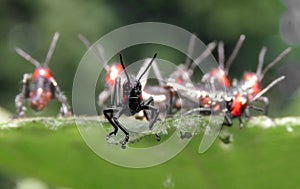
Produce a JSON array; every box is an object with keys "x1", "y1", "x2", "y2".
[{"x1": 231, "y1": 93, "x2": 248, "y2": 117}]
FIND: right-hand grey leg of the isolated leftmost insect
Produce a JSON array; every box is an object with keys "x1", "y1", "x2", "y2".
[{"x1": 50, "y1": 78, "x2": 72, "y2": 117}]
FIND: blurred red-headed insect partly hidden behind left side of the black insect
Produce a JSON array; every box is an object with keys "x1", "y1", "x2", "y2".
[{"x1": 78, "y1": 34, "x2": 123, "y2": 107}]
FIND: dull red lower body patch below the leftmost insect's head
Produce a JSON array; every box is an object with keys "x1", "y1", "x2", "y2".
[{"x1": 29, "y1": 88, "x2": 52, "y2": 111}]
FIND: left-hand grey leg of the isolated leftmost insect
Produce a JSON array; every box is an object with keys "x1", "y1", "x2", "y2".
[{"x1": 15, "y1": 74, "x2": 31, "y2": 117}]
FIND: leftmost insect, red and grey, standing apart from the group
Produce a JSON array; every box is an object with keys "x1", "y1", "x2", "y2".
[{"x1": 15, "y1": 32, "x2": 72, "y2": 117}]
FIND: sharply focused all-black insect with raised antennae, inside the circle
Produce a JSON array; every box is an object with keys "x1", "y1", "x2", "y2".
[{"x1": 103, "y1": 54, "x2": 160, "y2": 148}]
